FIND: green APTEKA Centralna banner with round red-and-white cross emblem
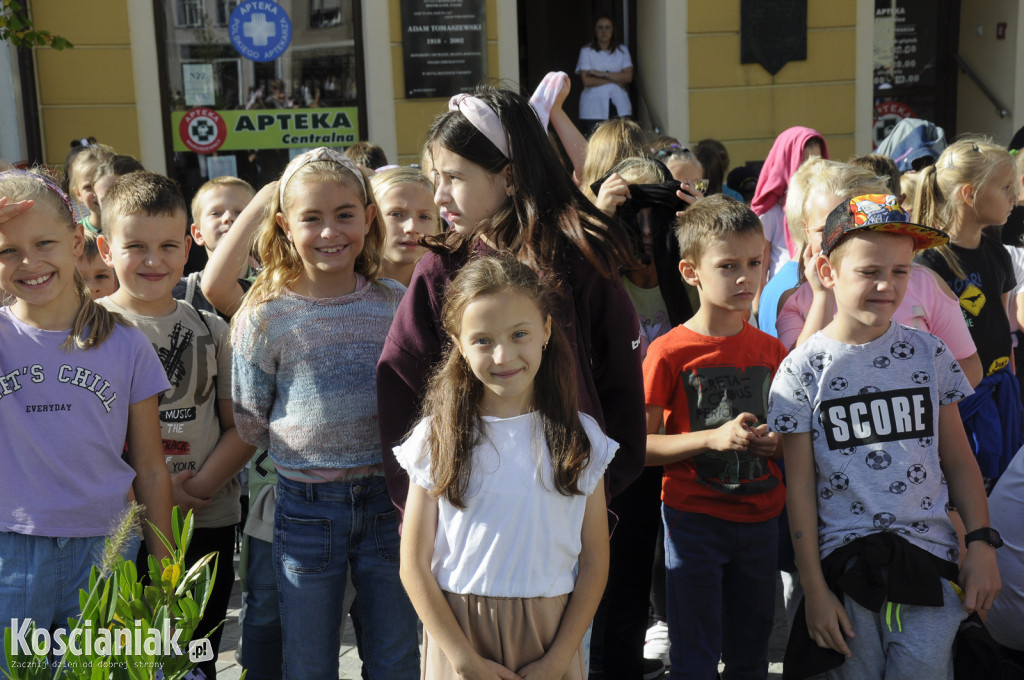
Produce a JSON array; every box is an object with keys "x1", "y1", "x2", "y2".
[{"x1": 171, "y1": 107, "x2": 359, "y2": 154}]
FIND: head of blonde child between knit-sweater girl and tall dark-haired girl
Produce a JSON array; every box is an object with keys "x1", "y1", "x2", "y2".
[{"x1": 370, "y1": 168, "x2": 441, "y2": 286}]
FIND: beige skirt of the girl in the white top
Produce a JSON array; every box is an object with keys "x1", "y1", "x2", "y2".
[{"x1": 421, "y1": 592, "x2": 587, "y2": 680}]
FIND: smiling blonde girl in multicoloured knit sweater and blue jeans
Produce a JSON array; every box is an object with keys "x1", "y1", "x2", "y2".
[{"x1": 231, "y1": 147, "x2": 419, "y2": 680}]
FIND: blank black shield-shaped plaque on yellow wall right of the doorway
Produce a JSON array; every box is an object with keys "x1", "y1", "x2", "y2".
[{"x1": 739, "y1": 0, "x2": 807, "y2": 76}]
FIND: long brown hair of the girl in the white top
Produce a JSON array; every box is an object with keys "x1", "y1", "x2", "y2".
[{"x1": 423, "y1": 255, "x2": 590, "y2": 509}]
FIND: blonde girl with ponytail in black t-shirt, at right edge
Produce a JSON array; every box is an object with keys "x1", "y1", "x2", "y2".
[{"x1": 913, "y1": 138, "x2": 1024, "y2": 479}]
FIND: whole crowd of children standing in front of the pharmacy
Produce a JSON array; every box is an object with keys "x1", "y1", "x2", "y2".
[{"x1": 0, "y1": 76, "x2": 1020, "y2": 680}]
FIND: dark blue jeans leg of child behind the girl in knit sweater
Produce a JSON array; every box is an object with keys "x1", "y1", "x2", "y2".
[{"x1": 242, "y1": 536, "x2": 281, "y2": 680}]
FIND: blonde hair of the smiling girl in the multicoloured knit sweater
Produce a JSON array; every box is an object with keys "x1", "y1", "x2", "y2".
[{"x1": 234, "y1": 161, "x2": 384, "y2": 318}]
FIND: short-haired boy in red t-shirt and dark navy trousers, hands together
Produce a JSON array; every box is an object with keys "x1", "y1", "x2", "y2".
[{"x1": 643, "y1": 196, "x2": 786, "y2": 680}]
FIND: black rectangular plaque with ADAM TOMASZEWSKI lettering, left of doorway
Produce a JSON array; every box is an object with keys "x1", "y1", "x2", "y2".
[{"x1": 399, "y1": 0, "x2": 487, "y2": 98}]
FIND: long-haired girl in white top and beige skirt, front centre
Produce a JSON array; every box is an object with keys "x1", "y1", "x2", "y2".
[{"x1": 395, "y1": 257, "x2": 617, "y2": 680}]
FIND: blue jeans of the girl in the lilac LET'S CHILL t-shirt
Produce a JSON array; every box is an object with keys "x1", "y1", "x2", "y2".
[{"x1": 0, "y1": 532, "x2": 105, "y2": 676}]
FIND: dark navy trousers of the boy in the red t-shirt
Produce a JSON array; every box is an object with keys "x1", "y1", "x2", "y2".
[{"x1": 662, "y1": 504, "x2": 778, "y2": 680}]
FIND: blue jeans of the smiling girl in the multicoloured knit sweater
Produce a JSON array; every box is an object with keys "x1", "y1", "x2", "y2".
[{"x1": 273, "y1": 476, "x2": 420, "y2": 680}]
